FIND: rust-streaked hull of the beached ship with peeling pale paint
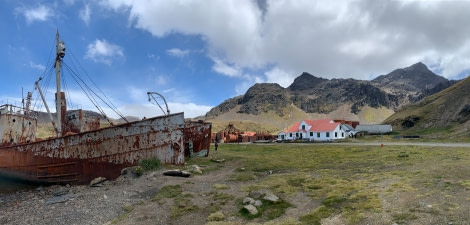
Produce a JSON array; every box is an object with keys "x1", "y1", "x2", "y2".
[{"x1": 0, "y1": 113, "x2": 184, "y2": 184}]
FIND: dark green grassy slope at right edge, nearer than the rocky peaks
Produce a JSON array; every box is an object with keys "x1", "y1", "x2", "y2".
[{"x1": 384, "y1": 77, "x2": 470, "y2": 135}]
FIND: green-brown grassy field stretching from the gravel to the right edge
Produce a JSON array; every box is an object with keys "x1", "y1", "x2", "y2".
[{"x1": 111, "y1": 142, "x2": 470, "y2": 225}]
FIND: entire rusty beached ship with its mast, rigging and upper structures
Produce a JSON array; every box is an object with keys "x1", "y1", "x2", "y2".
[{"x1": 0, "y1": 30, "x2": 212, "y2": 184}]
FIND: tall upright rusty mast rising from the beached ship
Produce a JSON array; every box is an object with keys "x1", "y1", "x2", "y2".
[{"x1": 55, "y1": 30, "x2": 65, "y2": 137}]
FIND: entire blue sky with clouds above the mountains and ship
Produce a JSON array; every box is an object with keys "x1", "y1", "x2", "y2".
[{"x1": 0, "y1": 0, "x2": 470, "y2": 118}]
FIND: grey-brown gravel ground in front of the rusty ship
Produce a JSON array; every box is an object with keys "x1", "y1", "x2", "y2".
[{"x1": 0, "y1": 159, "x2": 243, "y2": 225}]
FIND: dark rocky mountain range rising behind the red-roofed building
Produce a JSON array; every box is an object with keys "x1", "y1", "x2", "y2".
[{"x1": 206, "y1": 63, "x2": 456, "y2": 129}]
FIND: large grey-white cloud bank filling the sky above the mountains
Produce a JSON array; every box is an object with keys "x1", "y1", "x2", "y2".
[{"x1": 103, "y1": 0, "x2": 470, "y2": 83}]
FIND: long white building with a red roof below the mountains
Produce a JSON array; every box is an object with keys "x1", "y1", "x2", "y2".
[{"x1": 278, "y1": 119, "x2": 347, "y2": 141}]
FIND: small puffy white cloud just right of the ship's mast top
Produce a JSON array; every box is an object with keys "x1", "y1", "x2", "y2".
[{"x1": 85, "y1": 39, "x2": 124, "y2": 65}]
